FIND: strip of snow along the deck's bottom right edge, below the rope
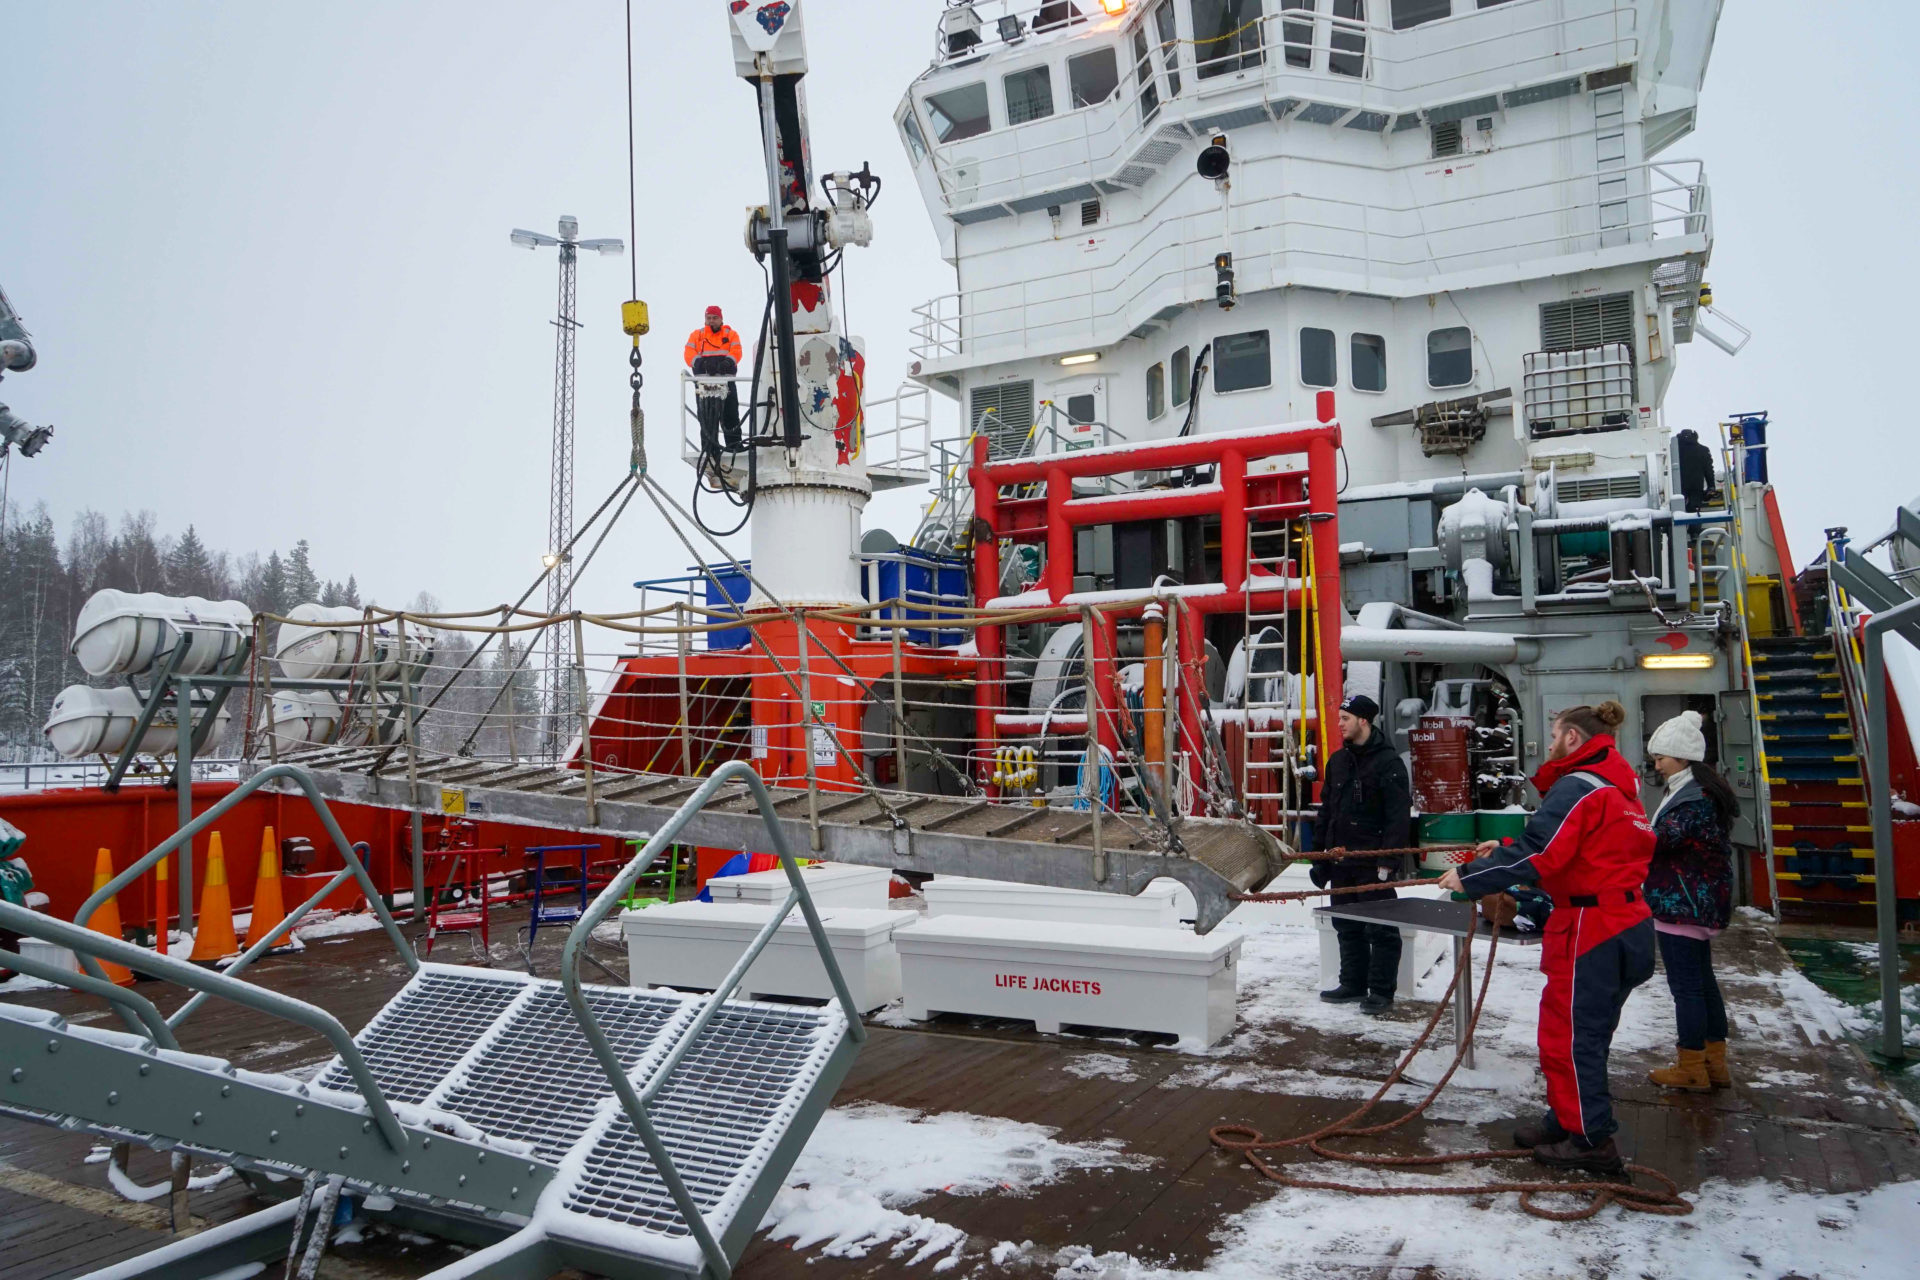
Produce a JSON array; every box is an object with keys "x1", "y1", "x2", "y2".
[{"x1": 1054, "y1": 1182, "x2": 1920, "y2": 1280}]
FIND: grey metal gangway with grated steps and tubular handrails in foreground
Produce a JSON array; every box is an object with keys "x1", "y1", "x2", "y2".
[{"x1": 0, "y1": 762, "x2": 866, "y2": 1280}]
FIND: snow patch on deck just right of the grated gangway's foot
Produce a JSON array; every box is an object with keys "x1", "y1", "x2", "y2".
[{"x1": 762, "y1": 1103, "x2": 1150, "y2": 1270}]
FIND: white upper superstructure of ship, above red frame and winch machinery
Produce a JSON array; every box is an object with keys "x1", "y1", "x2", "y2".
[{"x1": 897, "y1": 0, "x2": 1718, "y2": 499}]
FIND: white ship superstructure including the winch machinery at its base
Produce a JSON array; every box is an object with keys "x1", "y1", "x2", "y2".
[{"x1": 895, "y1": 0, "x2": 1764, "y2": 806}]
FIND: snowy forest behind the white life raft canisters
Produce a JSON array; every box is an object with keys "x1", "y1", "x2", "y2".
[{"x1": 0, "y1": 507, "x2": 540, "y2": 760}]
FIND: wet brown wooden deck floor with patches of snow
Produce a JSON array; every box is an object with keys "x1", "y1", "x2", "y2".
[{"x1": 0, "y1": 898, "x2": 1920, "y2": 1280}]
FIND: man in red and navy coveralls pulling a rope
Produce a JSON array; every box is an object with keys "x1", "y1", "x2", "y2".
[{"x1": 1440, "y1": 700, "x2": 1653, "y2": 1176}]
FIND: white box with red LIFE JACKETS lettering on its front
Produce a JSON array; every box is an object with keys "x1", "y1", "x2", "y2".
[{"x1": 893, "y1": 915, "x2": 1240, "y2": 1048}]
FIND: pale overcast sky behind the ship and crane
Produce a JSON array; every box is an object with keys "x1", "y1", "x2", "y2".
[{"x1": 0, "y1": 0, "x2": 1920, "y2": 610}]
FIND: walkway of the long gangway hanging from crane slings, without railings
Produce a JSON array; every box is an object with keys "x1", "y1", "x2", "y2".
[{"x1": 263, "y1": 747, "x2": 1286, "y2": 933}]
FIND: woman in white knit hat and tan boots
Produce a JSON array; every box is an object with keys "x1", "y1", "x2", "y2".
[{"x1": 1645, "y1": 712, "x2": 1740, "y2": 1092}]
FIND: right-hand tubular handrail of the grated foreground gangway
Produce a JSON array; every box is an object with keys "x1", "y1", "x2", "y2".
[{"x1": 561, "y1": 760, "x2": 866, "y2": 1280}]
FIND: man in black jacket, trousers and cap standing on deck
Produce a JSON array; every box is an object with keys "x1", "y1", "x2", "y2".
[{"x1": 1313, "y1": 693, "x2": 1413, "y2": 1013}]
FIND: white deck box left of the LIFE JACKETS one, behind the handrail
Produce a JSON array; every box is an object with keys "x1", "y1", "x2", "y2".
[{"x1": 620, "y1": 902, "x2": 918, "y2": 1013}]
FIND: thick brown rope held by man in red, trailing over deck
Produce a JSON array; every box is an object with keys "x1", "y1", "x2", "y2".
[{"x1": 1208, "y1": 898, "x2": 1693, "y2": 1222}]
